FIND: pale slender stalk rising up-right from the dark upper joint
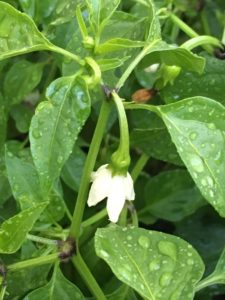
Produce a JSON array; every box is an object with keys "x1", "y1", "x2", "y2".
[{"x1": 116, "y1": 40, "x2": 158, "y2": 90}]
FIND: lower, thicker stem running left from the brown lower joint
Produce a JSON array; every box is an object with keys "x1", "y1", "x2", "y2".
[{"x1": 7, "y1": 253, "x2": 59, "y2": 272}]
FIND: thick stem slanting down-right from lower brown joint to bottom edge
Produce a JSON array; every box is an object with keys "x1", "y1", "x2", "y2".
[{"x1": 72, "y1": 253, "x2": 106, "y2": 300}]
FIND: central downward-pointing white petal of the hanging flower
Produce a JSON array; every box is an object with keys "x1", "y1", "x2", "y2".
[{"x1": 106, "y1": 176, "x2": 126, "y2": 223}]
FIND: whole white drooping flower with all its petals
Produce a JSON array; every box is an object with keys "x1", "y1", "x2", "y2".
[{"x1": 87, "y1": 165, "x2": 135, "y2": 223}]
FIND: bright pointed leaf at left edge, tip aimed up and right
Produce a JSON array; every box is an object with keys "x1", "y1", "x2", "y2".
[{"x1": 0, "y1": 202, "x2": 47, "y2": 254}]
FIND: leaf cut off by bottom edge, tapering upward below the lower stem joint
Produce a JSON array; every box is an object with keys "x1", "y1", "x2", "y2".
[{"x1": 23, "y1": 266, "x2": 85, "y2": 300}]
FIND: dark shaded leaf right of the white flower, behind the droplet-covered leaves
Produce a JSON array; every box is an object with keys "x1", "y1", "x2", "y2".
[{"x1": 140, "y1": 170, "x2": 206, "y2": 222}]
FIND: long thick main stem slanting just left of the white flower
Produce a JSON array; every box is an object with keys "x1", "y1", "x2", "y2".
[{"x1": 70, "y1": 101, "x2": 111, "y2": 241}]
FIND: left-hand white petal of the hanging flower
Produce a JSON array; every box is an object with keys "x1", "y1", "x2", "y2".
[{"x1": 87, "y1": 166, "x2": 112, "y2": 206}]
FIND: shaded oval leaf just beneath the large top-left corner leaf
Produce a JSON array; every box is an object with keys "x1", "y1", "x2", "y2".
[{"x1": 3, "y1": 59, "x2": 44, "y2": 105}]
